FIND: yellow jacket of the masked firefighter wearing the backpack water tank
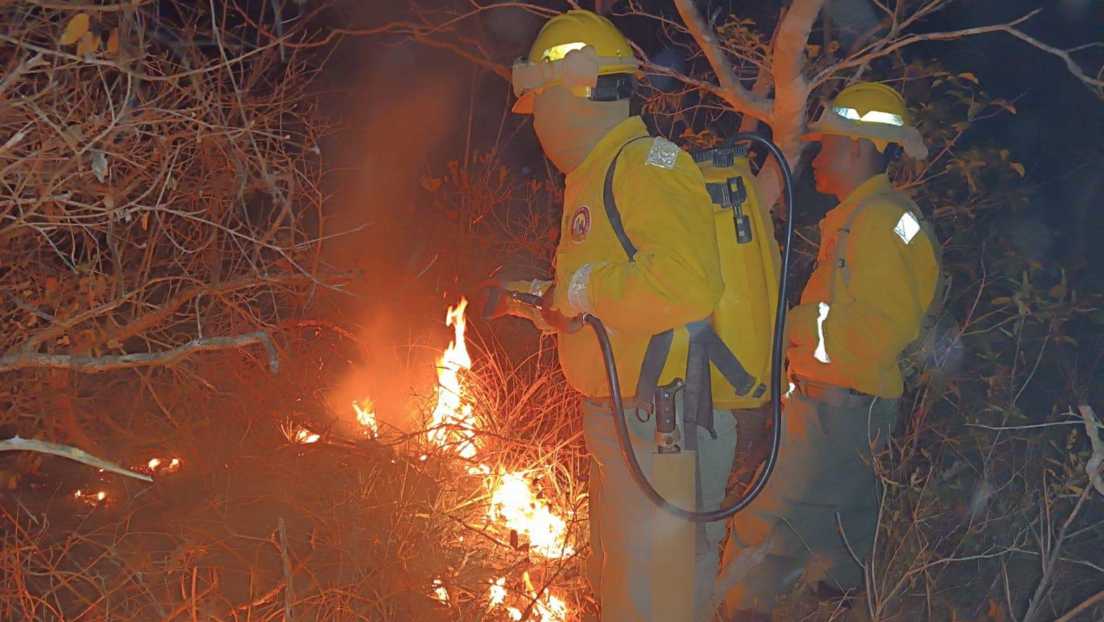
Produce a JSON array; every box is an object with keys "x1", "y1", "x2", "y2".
[{"x1": 553, "y1": 117, "x2": 724, "y2": 398}]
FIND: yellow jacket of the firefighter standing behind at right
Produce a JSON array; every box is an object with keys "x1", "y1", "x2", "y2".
[{"x1": 787, "y1": 175, "x2": 940, "y2": 398}]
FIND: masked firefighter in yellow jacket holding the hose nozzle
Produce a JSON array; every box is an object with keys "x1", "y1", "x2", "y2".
[{"x1": 490, "y1": 10, "x2": 735, "y2": 622}]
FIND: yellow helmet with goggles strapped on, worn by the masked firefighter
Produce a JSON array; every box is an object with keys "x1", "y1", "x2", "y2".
[{"x1": 512, "y1": 10, "x2": 644, "y2": 114}]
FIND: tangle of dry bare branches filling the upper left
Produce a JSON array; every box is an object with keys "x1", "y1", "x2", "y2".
[{"x1": 0, "y1": 2, "x2": 343, "y2": 451}]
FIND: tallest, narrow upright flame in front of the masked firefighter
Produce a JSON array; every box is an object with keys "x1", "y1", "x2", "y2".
[{"x1": 429, "y1": 298, "x2": 479, "y2": 458}]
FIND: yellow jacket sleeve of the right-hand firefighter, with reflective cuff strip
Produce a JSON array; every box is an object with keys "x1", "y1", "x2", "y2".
[{"x1": 792, "y1": 209, "x2": 931, "y2": 367}]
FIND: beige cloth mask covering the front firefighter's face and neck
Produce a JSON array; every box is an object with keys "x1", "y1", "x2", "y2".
[{"x1": 533, "y1": 87, "x2": 629, "y2": 173}]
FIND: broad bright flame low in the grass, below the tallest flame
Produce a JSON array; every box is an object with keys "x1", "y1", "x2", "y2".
[{"x1": 487, "y1": 473, "x2": 575, "y2": 559}]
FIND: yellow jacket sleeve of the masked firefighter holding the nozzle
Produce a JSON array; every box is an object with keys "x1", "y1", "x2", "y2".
[{"x1": 558, "y1": 154, "x2": 724, "y2": 336}]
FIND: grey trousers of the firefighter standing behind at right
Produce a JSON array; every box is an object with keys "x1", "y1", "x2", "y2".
[{"x1": 723, "y1": 381, "x2": 898, "y2": 613}]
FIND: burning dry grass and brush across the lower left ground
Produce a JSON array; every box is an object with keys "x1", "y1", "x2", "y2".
[{"x1": 0, "y1": 298, "x2": 592, "y2": 622}]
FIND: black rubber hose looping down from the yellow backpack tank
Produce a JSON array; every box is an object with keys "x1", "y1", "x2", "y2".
[{"x1": 596, "y1": 133, "x2": 794, "y2": 523}]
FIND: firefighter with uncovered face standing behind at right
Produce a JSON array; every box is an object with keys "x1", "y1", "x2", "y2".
[{"x1": 724, "y1": 83, "x2": 942, "y2": 620}]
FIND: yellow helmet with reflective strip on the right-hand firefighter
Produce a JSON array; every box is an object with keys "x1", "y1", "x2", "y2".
[{"x1": 802, "y1": 82, "x2": 927, "y2": 160}]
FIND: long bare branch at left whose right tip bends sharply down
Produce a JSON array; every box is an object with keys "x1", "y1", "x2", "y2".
[{"x1": 0, "y1": 330, "x2": 279, "y2": 373}]
